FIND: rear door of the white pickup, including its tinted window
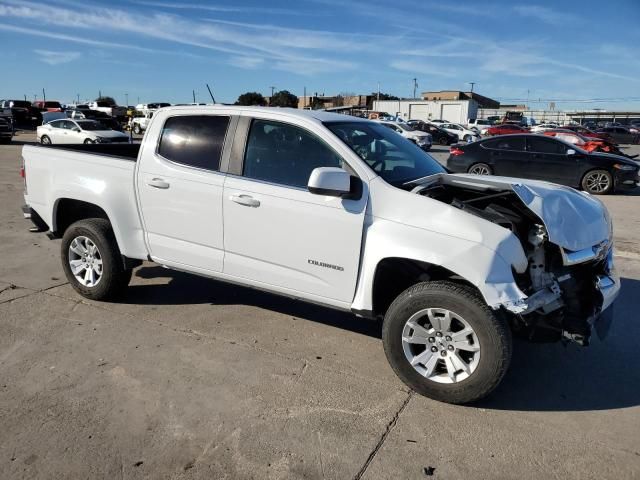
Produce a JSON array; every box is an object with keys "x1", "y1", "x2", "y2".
[{"x1": 137, "y1": 114, "x2": 235, "y2": 274}]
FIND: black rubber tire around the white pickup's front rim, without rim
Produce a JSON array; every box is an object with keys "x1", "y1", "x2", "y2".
[{"x1": 382, "y1": 281, "x2": 512, "y2": 404}]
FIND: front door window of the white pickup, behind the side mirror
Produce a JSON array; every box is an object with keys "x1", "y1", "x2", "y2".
[{"x1": 243, "y1": 120, "x2": 343, "y2": 188}]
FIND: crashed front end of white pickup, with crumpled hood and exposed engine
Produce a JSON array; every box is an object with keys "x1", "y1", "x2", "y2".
[{"x1": 413, "y1": 174, "x2": 620, "y2": 346}]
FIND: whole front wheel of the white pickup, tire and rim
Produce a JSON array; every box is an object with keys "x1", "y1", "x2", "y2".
[{"x1": 382, "y1": 281, "x2": 512, "y2": 404}]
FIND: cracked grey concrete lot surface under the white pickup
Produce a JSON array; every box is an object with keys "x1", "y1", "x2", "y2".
[{"x1": 0, "y1": 129, "x2": 640, "y2": 480}]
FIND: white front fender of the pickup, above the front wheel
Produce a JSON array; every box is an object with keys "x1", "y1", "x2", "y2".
[{"x1": 352, "y1": 179, "x2": 527, "y2": 311}]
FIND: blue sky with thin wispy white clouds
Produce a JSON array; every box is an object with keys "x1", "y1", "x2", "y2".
[{"x1": 0, "y1": 0, "x2": 640, "y2": 111}]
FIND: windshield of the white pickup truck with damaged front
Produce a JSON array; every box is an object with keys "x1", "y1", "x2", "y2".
[{"x1": 325, "y1": 121, "x2": 446, "y2": 187}]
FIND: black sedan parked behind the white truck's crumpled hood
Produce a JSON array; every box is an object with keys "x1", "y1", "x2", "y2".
[{"x1": 447, "y1": 135, "x2": 640, "y2": 195}]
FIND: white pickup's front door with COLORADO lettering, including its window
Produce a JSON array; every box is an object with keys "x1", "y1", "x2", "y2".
[{"x1": 224, "y1": 117, "x2": 368, "y2": 303}]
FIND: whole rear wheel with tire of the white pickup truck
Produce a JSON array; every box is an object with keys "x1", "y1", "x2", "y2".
[{"x1": 61, "y1": 218, "x2": 131, "y2": 300}]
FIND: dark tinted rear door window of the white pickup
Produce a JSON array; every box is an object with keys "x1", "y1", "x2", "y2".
[{"x1": 158, "y1": 115, "x2": 229, "y2": 171}]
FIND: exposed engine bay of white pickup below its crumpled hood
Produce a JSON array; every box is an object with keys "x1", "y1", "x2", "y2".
[{"x1": 412, "y1": 175, "x2": 613, "y2": 346}]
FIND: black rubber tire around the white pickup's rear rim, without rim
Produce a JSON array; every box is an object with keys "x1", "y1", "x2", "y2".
[{"x1": 61, "y1": 218, "x2": 132, "y2": 300}]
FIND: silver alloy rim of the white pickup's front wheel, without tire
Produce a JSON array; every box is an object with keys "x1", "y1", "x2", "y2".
[{"x1": 402, "y1": 308, "x2": 480, "y2": 383}]
